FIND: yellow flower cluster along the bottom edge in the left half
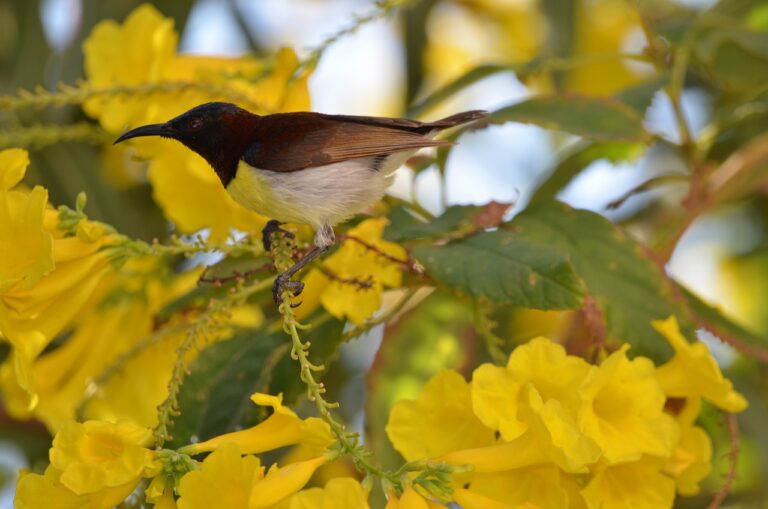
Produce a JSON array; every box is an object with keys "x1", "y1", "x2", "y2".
[{"x1": 15, "y1": 393, "x2": 367, "y2": 509}]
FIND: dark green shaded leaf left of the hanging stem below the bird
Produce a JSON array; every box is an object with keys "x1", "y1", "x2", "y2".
[{"x1": 168, "y1": 330, "x2": 288, "y2": 448}]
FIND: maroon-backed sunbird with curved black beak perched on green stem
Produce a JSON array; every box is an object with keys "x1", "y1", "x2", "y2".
[{"x1": 114, "y1": 102, "x2": 488, "y2": 305}]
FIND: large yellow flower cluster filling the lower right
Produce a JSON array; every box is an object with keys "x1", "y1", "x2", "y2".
[{"x1": 387, "y1": 317, "x2": 747, "y2": 509}]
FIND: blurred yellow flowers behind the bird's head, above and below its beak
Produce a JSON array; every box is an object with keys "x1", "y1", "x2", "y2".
[{"x1": 83, "y1": 4, "x2": 309, "y2": 241}]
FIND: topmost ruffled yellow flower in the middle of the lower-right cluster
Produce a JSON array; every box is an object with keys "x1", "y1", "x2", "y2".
[{"x1": 472, "y1": 338, "x2": 589, "y2": 441}]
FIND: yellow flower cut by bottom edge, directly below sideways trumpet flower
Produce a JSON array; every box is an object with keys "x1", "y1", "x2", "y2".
[{"x1": 177, "y1": 444, "x2": 264, "y2": 509}]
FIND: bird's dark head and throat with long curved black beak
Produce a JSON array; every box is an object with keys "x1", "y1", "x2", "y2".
[{"x1": 115, "y1": 102, "x2": 259, "y2": 186}]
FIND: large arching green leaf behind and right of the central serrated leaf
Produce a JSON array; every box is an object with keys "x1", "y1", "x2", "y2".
[{"x1": 511, "y1": 202, "x2": 693, "y2": 359}]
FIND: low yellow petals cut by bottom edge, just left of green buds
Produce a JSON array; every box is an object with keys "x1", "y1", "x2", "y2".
[{"x1": 274, "y1": 477, "x2": 369, "y2": 509}]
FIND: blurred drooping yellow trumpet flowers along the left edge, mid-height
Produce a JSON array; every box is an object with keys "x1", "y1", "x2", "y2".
[{"x1": 0, "y1": 149, "x2": 261, "y2": 432}]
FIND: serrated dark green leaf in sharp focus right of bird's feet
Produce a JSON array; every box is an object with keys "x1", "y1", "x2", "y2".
[{"x1": 412, "y1": 230, "x2": 583, "y2": 309}]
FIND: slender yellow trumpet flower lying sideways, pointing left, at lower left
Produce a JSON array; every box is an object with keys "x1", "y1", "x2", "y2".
[{"x1": 180, "y1": 393, "x2": 334, "y2": 454}]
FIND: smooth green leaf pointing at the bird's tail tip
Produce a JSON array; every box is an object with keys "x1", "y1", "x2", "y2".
[{"x1": 490, "y1": 95, "x2": 648, "y2": 141}]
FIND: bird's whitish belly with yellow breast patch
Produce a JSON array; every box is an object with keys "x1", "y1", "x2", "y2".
[{"x1": 227, "y1": 152, "x2": 412, "y2": 230}]
